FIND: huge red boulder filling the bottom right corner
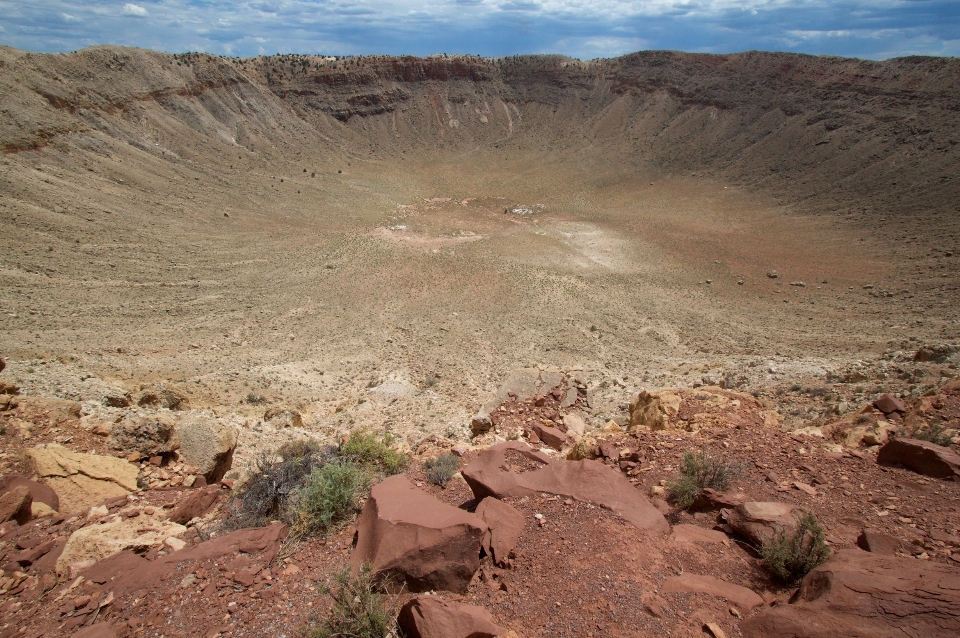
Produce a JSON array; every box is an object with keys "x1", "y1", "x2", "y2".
[{"x1": 740, "y1": 549, "x2": 960, "y2": 638}]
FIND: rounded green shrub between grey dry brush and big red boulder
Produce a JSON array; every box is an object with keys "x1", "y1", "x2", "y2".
[{"x1": 294, "y1": 462, "x2": 369, "y2": 535}]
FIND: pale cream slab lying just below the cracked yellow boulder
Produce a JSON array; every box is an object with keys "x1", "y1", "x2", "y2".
[{"x1": 57, "y1": 513, "x2": 187, "y2": 576}]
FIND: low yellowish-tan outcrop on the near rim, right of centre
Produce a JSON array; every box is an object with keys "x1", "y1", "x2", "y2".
[{"x1": 629, "y1": 386, "x2": 782, "y2": 431}]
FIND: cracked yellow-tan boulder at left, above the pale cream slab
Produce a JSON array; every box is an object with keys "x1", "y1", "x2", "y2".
[{"x1": 27, "y1": 443, "x2": 140, "y2": 515}]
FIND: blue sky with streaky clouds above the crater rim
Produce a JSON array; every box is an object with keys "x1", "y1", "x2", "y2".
[{"x1": 0, "y1": 0, "x2": 960, "y2": 59}]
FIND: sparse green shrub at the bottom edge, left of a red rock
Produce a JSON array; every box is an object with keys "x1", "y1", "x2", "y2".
[{"x1": 309, "y1": 565, "x2": 396, "y2": 638}]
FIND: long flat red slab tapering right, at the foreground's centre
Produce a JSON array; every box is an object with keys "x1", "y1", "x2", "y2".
[{"x1": 461, "y1": 441, "x2": 670, "y2": 533}]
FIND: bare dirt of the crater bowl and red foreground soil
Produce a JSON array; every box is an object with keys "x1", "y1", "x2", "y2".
[{"x1": 0, "y1": 47, "x2": 960, "y2": 636}]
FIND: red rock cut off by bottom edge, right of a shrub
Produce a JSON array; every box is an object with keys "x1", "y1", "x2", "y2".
[{"x1": 397, "y1": 596, "x2": 507, "y2": 638}]
